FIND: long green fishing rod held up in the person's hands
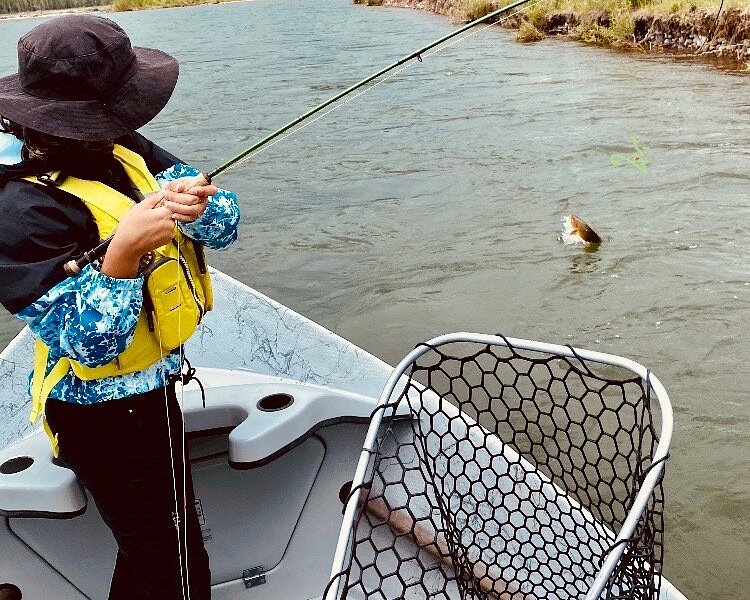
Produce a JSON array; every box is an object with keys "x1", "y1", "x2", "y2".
[{"x1": 63, "y1": 0, "x2": 539, "y2": 276}]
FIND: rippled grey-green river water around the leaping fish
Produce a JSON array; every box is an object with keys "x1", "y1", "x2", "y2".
[{"x1": 0, "y1": 0, "x2": 750, "y2": 600}]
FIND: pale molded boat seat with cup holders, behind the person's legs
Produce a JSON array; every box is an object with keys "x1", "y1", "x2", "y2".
[{"x1": 0, "y1": 369, "x2": 406, "y2": 518}]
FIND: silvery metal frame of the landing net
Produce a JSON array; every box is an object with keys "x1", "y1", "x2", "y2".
[{"x1": 323, "y1": 332, "x2": 674, "y2": 600}]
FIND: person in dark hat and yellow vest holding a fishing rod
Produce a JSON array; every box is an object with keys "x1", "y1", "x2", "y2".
[{"x1": 0, "y1": 15, "x2": 239, "y2": 600}]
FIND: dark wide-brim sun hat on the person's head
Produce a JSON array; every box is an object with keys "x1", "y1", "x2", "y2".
[{"x1": 0, "y1": 14, "x2": 179, "y2": 141}]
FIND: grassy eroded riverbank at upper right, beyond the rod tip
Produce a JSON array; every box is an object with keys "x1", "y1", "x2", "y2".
[{"x1": 362, "y1": 0, "x2": 750, "y2": 67}]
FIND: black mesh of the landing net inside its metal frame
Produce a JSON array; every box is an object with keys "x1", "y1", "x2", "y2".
[{"x1": 329, "y1": 342, "x2": 663, "y2": 600}]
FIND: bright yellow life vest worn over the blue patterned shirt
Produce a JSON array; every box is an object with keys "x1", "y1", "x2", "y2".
[{"x1": 26, "y1": 145, "x2": 213, "y2": 455}]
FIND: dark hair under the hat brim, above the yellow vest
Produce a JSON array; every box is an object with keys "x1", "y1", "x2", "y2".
[{"x1": 0, "y1": 116, "x2": 114, "y2": 183}]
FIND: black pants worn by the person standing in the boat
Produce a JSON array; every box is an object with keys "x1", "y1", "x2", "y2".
[{"x1": 45, "y1": 385, "x2": 211, "y2": 600}]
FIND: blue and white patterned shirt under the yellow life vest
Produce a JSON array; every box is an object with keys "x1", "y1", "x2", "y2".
[{"x1": 16, "y1": 164, "x2": 240, "y2": 404}]
